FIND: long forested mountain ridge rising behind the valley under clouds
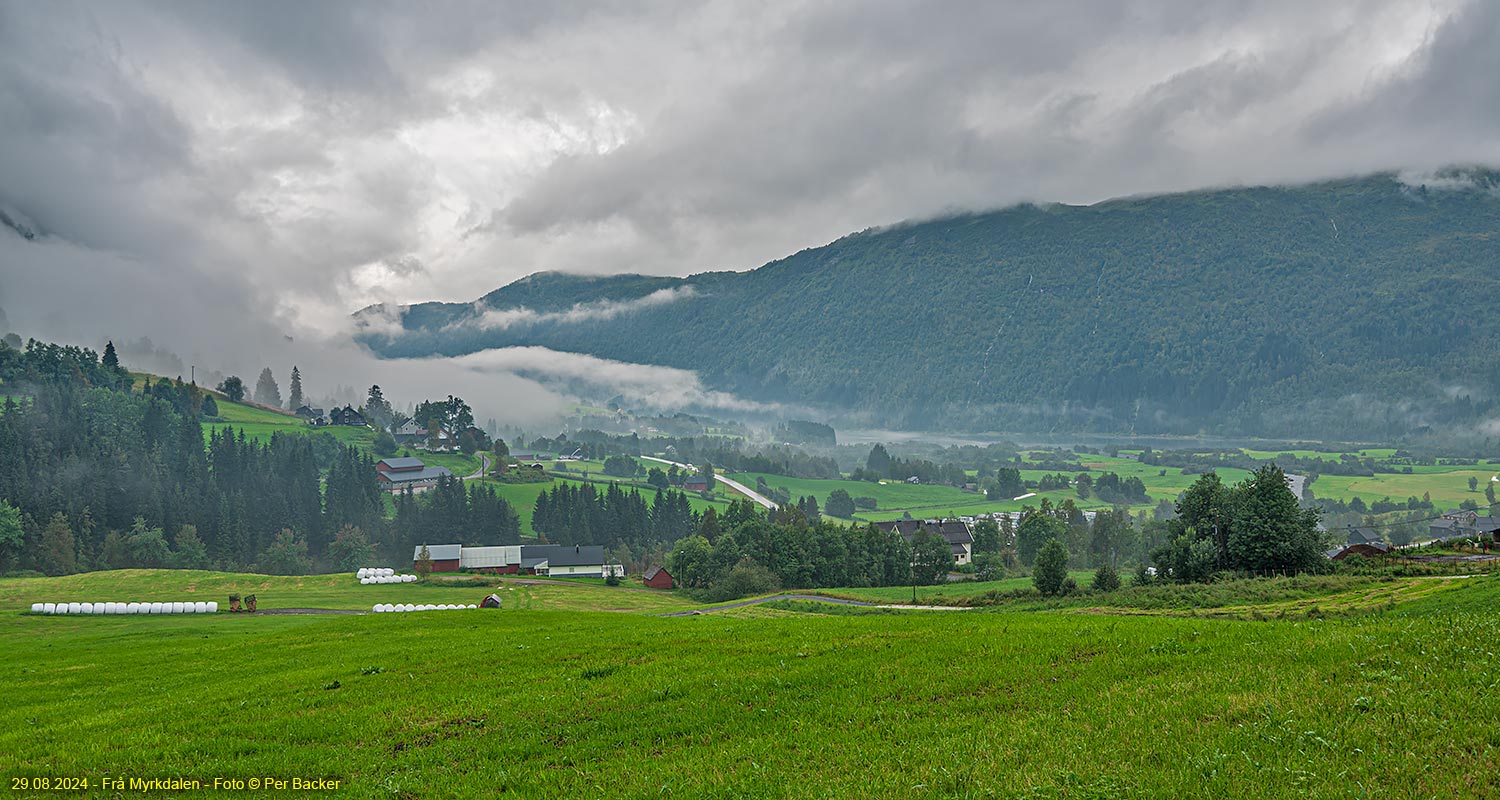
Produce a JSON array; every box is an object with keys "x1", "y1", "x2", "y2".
[{"x1": 360, "y1": 170, "x2": 1500, "y2": 440}]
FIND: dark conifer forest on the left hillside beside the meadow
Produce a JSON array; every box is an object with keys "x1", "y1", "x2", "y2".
[{"x1": 0, "y1": 341, "x2": 521, "y2": 575}]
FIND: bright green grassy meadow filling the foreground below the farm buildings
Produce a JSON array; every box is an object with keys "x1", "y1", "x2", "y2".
[{"x1": 0, "y1": 570, "x2": 1500, "y2": 797}]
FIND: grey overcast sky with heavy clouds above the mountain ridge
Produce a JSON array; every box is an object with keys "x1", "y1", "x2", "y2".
[{"x1": 0, "y1": 0, "x2": 1500, "y2": 420}]
